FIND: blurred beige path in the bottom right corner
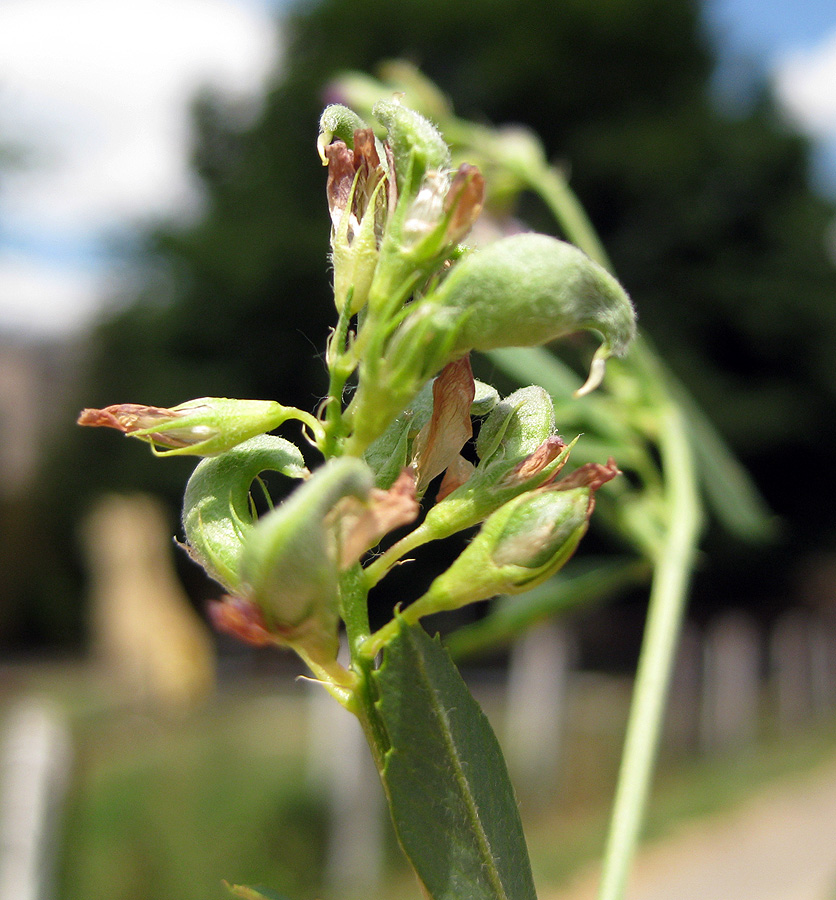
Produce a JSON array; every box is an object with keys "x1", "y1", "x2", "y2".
[{"x1": 542, "y1": 761, "x2": 836, "y2": 900}]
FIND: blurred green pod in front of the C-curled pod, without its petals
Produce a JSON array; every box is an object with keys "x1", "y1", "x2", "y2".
[{"x1": 240, "y1": 457, "x2": 374, "y2": 655}]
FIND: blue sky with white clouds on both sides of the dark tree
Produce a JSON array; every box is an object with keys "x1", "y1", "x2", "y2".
[{"x1": 0, "y1": 0, "x2": 836, "y2": 338}]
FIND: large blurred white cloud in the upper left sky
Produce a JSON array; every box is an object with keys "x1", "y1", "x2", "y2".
[{"x1": 0, "y1": 0, "x2": 276, "y2": 236}]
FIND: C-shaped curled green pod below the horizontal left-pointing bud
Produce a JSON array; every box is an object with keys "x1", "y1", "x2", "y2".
[{"x1": 183, "y1": 435, "x2": 308, "y2": 591}]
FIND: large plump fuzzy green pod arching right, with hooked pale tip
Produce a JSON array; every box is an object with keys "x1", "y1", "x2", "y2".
[{"x1": 391, "y1": 234, "x2": 635, "y2": 391}]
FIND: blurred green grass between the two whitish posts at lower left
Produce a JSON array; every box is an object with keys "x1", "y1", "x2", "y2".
[{"x1": 54, "y1": 689, "x2": 325, "y2": 900}]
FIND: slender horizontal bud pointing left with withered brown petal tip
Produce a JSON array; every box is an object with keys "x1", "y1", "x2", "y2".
[{"x1": 78, "y1": 397, "x2": 298, "y2": 456}]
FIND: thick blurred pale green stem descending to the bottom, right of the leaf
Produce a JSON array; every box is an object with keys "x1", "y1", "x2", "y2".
[{"x1": 598, "y1": 404, "x2": 701, "y2": 900}]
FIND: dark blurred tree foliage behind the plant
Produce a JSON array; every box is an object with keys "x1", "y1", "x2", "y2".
[{"x1": 20, "y1": 0, "x2": 836, "y2": 641}]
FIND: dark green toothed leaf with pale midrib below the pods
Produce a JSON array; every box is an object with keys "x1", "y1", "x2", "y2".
[{"x1": 373, "y1": 622, "x2": 535, "y2": 900}]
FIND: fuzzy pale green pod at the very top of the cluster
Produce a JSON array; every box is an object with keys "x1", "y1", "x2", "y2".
[{"x1": 372, "y1": 100, "x2": 450, "y2": 197}]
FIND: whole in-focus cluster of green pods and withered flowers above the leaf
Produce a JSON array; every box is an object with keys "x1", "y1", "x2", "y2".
[{"x1": 79, "y1": 89, "x2": 635, "y2": 691}]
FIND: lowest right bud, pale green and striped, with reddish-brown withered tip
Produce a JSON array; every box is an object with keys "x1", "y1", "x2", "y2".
[{"x1": 406, "y1": 460, "x2": 618, "y2": 621}]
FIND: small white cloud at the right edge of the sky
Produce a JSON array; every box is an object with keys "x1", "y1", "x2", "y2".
[{"x1": 775, "y1": 31, "x2": 836, "y2": 140}]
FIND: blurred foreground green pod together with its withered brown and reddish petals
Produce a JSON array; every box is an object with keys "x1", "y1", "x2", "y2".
[{"x1": 209, "y1": 457, "x2": 418, "y2": 681}]
